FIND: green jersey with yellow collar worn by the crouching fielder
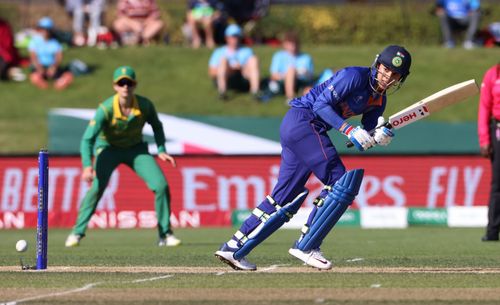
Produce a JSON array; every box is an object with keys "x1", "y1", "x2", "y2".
[{"x1": 80, "y1": 94, "x2": 166, "y2": 167}]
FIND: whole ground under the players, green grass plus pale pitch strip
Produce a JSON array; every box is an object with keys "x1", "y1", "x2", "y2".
[{"x1": 0, "y1": 228, "x2": 500, "y2": 304}]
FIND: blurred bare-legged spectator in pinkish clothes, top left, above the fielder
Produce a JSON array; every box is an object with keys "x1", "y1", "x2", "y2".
[{"x1": 113, "y1": 0, "x2": 164, "y2": 45}]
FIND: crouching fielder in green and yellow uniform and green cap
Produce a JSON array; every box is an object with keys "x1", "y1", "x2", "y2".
[{"x1": 66, "y1": 66, "x2": 181, "y2": 247}]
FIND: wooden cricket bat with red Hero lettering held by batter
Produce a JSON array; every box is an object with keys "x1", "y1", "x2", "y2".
[{"x1": 347, "y1": 79, "x2": 479, "y2": 147}]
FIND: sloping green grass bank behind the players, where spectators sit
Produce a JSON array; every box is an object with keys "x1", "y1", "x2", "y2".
[{"x1": 0, "y1": 46, "x2": 498, "y2": 154}]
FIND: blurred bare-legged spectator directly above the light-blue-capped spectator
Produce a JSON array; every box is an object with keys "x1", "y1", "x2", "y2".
[{"x1": 186, "y1": 0, "x2": 220, "y2": 49}]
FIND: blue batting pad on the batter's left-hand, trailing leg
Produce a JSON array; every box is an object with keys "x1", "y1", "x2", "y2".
[{"x1": 233, "y1": 189, "x2": 309, "y2": 260}]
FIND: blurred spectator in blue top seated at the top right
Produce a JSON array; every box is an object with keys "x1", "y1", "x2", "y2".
[{"x1": 436, "y1": 0, "x2": 481, "y2": 49}]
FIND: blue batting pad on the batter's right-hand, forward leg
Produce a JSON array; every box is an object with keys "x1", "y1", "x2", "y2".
[{"x1": 297, "y1": 169, "x2": 364, "y2": 251}]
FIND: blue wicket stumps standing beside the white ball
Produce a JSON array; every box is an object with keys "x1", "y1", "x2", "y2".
[{"x1": 36, "y1": 149, "x2": 49, "y2": 270}]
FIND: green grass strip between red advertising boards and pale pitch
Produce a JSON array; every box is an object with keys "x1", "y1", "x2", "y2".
[{"x1": 0, "y1": 228, "x2": 500, "y2": 268}]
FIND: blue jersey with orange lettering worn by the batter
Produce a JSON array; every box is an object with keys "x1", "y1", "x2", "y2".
[{"x1": 290, "y1": 67, "x2": 387, "y2": 130}]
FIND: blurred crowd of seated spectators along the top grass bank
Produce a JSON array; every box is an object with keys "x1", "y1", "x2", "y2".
[{"x1": 0, "y1": 0, "x2": 500, "y2": 102}]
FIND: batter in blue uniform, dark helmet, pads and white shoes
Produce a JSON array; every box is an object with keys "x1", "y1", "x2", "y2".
[{"x1": 215, "y1": 45, "x2": 411, "y2": 270}]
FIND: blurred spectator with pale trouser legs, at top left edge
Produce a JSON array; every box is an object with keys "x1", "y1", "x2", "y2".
[{"x1": 66, "y1": 0, "x2": 106, "y2": 46}]
